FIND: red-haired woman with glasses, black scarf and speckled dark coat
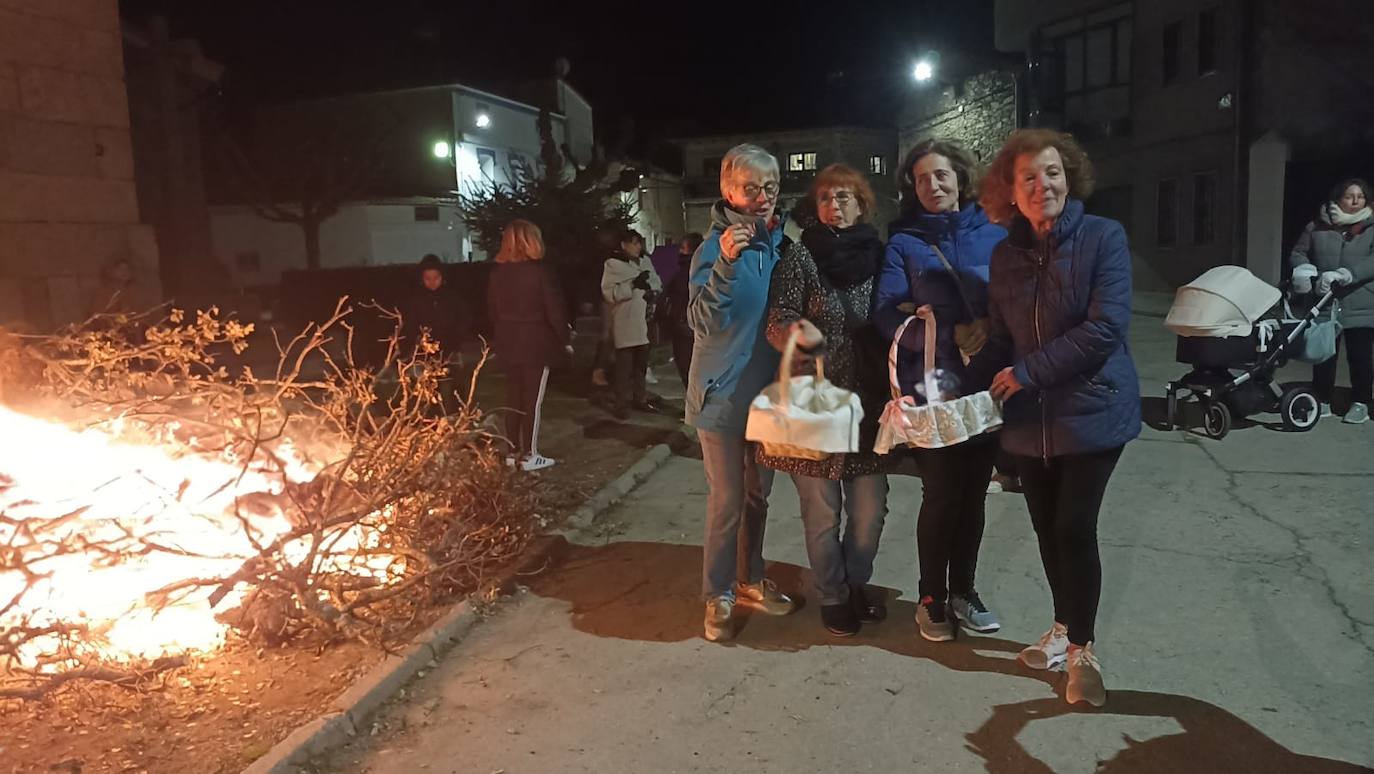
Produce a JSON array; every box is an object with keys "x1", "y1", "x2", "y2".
[{"x1": 758, "y1": 164, "x2": 890, "y2": 637}]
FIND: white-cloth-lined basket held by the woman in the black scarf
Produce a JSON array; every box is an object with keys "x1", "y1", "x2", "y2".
[{"x1": 745, "y1": 331, "x2": 863, "y2": 456}]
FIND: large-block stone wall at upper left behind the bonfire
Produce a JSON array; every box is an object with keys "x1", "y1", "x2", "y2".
[{"x1": 0, "y1": 0, "x2": 158, "y2": 330}]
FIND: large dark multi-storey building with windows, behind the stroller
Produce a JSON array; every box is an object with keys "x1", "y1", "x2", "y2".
[{"x1": 996, "y1": 0, "x2": 1374, "y2": 287}]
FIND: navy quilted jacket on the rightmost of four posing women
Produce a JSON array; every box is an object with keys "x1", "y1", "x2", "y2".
[{"x1": 970, "y1": 199, "x2": 1140, "y2": 459}]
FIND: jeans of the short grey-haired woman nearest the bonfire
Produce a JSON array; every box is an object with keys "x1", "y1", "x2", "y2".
[{"x1": 697, "y1": 430, "x2": 774, "y2": 599}]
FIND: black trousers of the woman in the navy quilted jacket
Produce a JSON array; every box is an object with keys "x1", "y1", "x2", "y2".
[{"x1": 1017, "y1": 447, "x2": 1121, "y2": 645}]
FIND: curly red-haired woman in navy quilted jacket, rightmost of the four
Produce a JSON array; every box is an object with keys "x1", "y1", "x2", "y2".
[{"x1": 970, "y1": 129, "x2": 1140, "y2": 707}]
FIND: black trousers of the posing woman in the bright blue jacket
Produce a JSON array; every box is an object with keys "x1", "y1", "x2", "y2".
[{"x1": 916, "y1": 437, "x2": 998, "y2": 602}]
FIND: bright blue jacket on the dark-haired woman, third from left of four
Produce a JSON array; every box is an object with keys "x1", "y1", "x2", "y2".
[{"x1": 874, "y1": 203, "x2": 1007, "y2": 395}]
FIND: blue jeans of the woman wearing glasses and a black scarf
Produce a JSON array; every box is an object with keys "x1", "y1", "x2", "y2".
[{"x1": 791, "y1": 474, "x2": 888, "y2": 605}]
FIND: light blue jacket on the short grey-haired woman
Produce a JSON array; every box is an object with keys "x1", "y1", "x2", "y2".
[{"x1": 687, "y1": 202, "x2": 785, "y2": 436}]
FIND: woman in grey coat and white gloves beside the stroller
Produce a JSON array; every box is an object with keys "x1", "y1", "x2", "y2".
[{"x1": 1289, "y1": 177, "x2": 1374, "y2": 425}]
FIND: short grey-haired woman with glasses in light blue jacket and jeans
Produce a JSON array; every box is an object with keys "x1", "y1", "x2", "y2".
[{"x1": 687, "y1": 143, "x2": 796, "y2": 642}]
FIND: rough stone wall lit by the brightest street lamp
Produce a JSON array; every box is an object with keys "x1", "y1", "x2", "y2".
[{"x1": 897, "y1": 70, "x2": 1017, "y2": 161}]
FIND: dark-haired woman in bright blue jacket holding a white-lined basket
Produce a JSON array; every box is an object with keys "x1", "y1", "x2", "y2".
[{"x1": 874, "y1": 139, "x2": 1007, "y2": 642}]
